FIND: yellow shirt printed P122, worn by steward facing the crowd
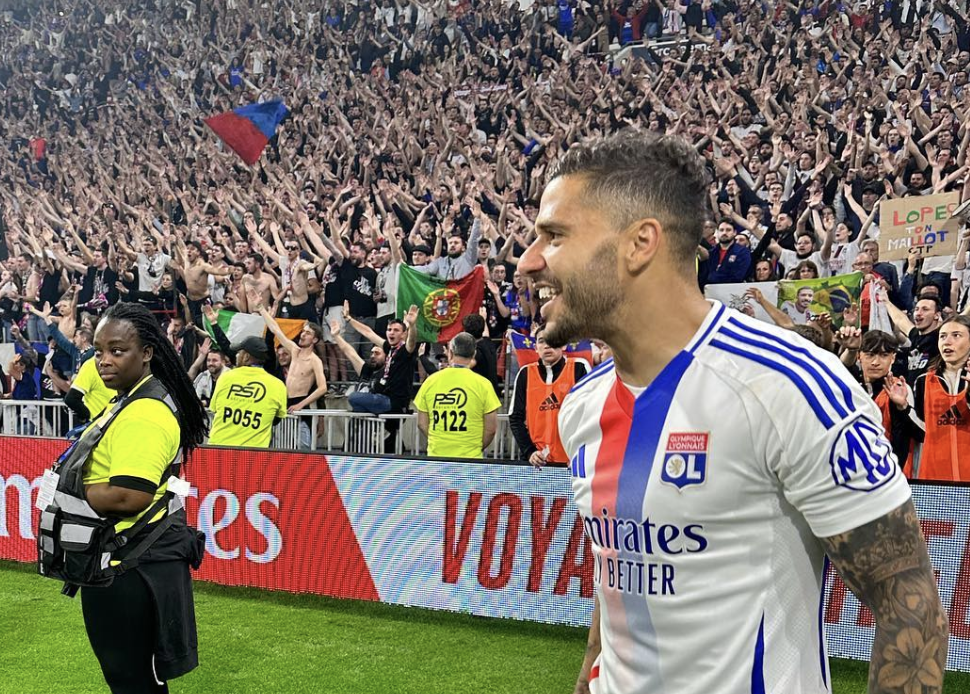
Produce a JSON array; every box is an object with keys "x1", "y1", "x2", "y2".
[{"x1": 414, "y1": 367, "x2": 502, "y2": 458}]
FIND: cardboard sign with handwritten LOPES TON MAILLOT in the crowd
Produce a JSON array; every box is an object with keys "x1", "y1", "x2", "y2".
[{"x1": 878, "y1": 193, "x2": 961, "y2": 262}]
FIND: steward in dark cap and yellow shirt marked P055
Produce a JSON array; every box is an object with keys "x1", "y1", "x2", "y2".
[{"x1": 209, "y1": 337, "x2": 286, "y2": 448}]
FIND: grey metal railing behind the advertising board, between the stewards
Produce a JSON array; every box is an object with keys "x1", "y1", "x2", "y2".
[{"x1": 0, "y1": 400, "x2": 516, "y2": 460}]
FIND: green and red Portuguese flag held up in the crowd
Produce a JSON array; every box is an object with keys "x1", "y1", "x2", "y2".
[{"x1": 397, "y1": 265, "x2": 485, "y2": 342}]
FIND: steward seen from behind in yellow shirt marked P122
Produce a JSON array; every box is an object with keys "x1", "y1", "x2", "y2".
[{"x1": 414, "y1": 333, "x2": 501, "y2": 458}]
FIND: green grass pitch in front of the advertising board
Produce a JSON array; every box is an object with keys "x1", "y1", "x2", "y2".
[{"x1": 0, "y1": 562, "x2": 970, "y2": 694}]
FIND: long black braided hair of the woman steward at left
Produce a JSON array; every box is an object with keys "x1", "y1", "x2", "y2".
[{"x1": 102, "y1": 303, "x2": 209, "y2": 454}]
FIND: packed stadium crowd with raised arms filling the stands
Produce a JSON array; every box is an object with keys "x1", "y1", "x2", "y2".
[{"x1": 0, "y1": 0, "x2": 970, "y2": 476}]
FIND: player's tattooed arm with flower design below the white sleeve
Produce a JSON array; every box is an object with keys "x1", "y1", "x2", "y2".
[{"x1": 822, "y1": 501, "x2": 949, "y2": 694}]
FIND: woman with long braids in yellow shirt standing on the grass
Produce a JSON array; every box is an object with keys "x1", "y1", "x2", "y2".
[{"x1": 77, "y1": 303, "x2": 208, "y2": 694}]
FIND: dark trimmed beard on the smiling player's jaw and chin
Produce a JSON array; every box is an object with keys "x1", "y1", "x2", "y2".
[{"x1": 544, "y1": 239, "x2": 622, "y2": 347}]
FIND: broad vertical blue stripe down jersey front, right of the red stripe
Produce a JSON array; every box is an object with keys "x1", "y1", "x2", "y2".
[{"x1": 616, "y1": 352, "x2": 694, "y2": 688}]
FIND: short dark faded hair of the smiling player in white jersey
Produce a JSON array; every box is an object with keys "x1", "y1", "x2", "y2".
[{"x1": 549, "y1": 129, "x2": 711, "y2": 263}]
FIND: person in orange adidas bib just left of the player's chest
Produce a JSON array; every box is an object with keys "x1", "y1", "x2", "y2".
[{"x1": 509, "y1": 328, "x2": 589, "y2": 467}]
